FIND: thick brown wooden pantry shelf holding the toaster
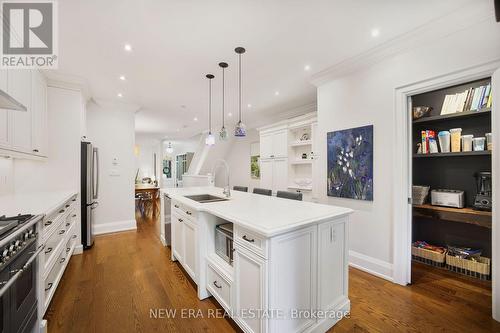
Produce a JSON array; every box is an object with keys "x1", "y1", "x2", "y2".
[{"x1": 413, "y1": 204, "x2": 492, "y2": 229}]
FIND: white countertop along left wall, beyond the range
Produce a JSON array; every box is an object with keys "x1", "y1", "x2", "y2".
[{"x1": 0, "y1": 191, "x2": 77, "y2": 216}]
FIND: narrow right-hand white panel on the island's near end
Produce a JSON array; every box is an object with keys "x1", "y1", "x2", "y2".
[{"x1": 318, "y1": 222, "x2": 348, "y2": 309}]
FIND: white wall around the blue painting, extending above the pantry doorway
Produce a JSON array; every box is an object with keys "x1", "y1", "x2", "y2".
[{"x1": 318, "y1": 19, "x2": 500, "y2": 279}]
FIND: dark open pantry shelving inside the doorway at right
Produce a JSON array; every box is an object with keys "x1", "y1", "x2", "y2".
[{"x1": 411, "y1": 78, "x2": 492, "y2": 282}]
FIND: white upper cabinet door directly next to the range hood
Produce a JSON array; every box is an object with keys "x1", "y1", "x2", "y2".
[{"x1": 7, "y1": 69, "x2": 32, "y2": 153}]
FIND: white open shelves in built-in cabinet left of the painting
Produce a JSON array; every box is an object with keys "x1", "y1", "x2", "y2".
[{"x1": 288, "y1": 122, "x2": 314, "y2": 191}]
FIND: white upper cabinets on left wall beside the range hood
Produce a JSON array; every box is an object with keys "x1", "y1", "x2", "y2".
[{"x1": 0, "y1": 69, "x2": 48, "y2": 158}]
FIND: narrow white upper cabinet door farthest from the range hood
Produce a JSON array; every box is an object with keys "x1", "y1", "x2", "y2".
[{"x1": 31, "y1": 71, "x2": 48, "y2": 156}]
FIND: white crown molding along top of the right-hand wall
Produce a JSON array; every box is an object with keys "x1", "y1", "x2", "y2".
[{"x1": 310, "y1": 1, "x2": 495, "y2": 86}]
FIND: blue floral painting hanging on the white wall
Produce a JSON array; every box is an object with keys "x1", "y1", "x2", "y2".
[{"x1": 327, "y1": 125, "x2": 373, "y2": 201}]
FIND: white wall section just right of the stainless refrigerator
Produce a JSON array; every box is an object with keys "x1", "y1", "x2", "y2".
[{"x1": 87, "y1": 102, "x2": 136, "y2": 234}]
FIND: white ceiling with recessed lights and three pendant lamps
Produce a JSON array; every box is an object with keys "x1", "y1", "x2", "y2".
[{"x1": 53, "y1": 0, "x2": 474, "y2": 138}]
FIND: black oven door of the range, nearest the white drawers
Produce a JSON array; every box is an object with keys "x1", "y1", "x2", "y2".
[{"x1": 10, "y1": 242, "x2": 37, "y2": 333}]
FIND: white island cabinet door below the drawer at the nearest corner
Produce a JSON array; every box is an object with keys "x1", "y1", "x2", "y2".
[{"x1": 234, "y1": 244, "x2": 267, "y2": 333}]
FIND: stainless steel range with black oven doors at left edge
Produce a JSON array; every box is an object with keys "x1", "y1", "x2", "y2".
[{"x1": 0, "y1": 215, "x2": 43, "y2": 333}]
